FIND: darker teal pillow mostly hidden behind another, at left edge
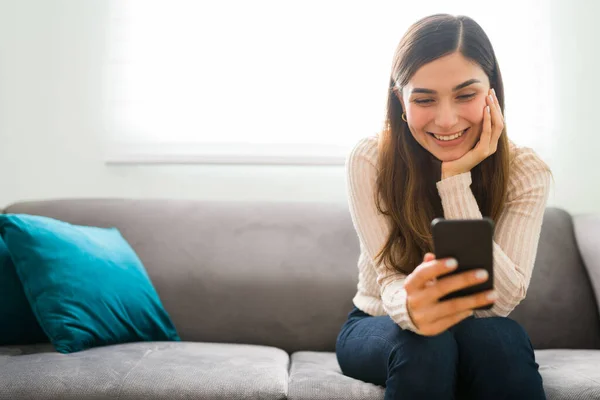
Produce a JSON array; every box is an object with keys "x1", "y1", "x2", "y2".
[{"x1": 0, "y1": 238, "x2": 48, "y2": 346}]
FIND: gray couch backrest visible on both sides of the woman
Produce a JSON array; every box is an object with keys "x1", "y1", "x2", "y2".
[{"x1": 5, "y1": 199, "x2": 600, "y2": 352}]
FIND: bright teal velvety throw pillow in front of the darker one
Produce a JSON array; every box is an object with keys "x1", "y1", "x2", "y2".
[{"x1": 0, "y1": 214, "x2": 179, "y2": 353}]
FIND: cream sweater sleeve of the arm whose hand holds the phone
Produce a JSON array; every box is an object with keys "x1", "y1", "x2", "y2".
[{"x1": 346, "y1": 142, "x2": 418, "y2": 333}]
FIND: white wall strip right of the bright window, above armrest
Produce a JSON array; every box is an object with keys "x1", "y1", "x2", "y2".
[{"x1": 551, "y1": 0, "x2": 600, "y2": 213}]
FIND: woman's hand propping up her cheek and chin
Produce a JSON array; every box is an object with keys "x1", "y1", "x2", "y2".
[{"x1": 442, "y1": 89, "x2": 504, "y2": 179}]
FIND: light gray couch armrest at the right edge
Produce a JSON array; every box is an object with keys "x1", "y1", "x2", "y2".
[{"x1": 573, "y1": 214, "x2": 600, "y2": 309}]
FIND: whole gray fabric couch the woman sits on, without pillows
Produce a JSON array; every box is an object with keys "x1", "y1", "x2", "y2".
[{"x1": 0, "y1": 199, "x2": 600, "y2": 400}]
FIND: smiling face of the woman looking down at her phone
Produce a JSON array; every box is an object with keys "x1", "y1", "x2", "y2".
[{"x1": 401, "y1": 52, "x2": 490, "y2": 162}]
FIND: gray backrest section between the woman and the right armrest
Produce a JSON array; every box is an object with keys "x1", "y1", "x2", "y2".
[{"x1": 510, "y1": 208, "x2": 600, "y2": 349}]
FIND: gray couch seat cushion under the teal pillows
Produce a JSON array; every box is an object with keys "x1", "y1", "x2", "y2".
[{"x1": 0, "y1": 342, "x2": 289, "y2": 400}]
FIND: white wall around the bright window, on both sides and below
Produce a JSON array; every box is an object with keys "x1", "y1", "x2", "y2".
[{"x1": 0, "y1": 0, "x2": 600, "y2": 213}]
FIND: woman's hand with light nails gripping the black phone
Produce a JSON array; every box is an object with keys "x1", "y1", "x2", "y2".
[{"x1": 404, "y1": 253, "x2": 495, "y2": 336}]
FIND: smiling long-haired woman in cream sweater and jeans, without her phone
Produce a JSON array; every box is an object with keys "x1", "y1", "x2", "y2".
[{"x1": 336, "y1": 15, "x2": 551, "y2": 400}]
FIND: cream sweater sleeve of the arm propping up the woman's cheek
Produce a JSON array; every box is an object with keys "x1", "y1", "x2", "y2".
[{"x1": 437, "y1": 149, "x2": 550, "y2": 317}]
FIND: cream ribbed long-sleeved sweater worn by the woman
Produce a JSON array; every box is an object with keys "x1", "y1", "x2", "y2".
[{"x1": 346, "y1": 136, "x2": 551, "y2": 333}]
